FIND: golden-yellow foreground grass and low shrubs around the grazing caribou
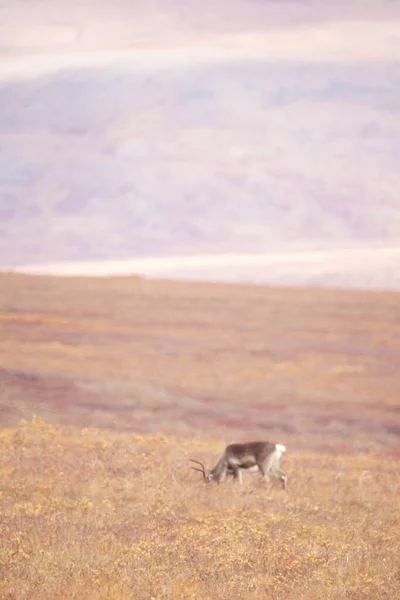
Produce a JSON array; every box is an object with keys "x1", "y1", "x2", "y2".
[{"x1": 0, "y1": 418, "x2": 400, "y2": 600}]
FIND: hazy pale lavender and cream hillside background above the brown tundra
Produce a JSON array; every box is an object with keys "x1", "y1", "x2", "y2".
[{"x1": 0, "y1": 0, "x2": 400, "y2": 288}]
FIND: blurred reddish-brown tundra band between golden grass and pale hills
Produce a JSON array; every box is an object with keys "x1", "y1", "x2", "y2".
[{"x1": 0, "y1": 275, "x2": 400, "y2": 452}]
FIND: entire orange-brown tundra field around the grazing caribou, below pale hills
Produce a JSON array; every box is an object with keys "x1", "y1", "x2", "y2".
[{"x1": 0, "y1": 275, "x2": 400, "y2": 600}]
